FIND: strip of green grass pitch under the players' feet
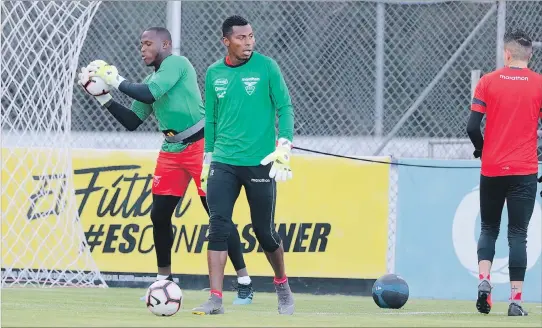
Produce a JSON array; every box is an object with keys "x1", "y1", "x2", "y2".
[{"x1": 1, "y1": 288, "x2": 542, "y2": 328}]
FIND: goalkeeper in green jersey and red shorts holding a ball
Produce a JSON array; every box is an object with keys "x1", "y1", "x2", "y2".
[{"x1": 79, "y1": 27, "x2": 253, "y2": 304}]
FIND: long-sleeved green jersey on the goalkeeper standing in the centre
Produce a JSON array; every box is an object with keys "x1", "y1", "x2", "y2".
[{"x1": 205, "y1": 52, "x2": 294, "y2": 166}]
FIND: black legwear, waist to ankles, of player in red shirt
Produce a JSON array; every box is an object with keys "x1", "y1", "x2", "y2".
[{"x1": 478, "y1": 174, "x2": 537, "y2": 281}]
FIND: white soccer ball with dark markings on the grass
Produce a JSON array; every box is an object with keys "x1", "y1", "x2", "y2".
[{"x1": 145, "y1": 280, "x2": 183, "y2": 317}]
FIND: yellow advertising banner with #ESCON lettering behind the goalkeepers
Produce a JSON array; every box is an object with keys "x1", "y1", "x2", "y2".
[{"x1": 2, "y1": 150, "x2": 389, "y2": 279}]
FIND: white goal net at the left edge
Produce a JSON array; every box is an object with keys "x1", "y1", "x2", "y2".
[{"x1": 0, "y1": 1, "x2": 106, "y2": 287}]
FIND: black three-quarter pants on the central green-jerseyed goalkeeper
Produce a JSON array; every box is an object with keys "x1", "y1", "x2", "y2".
[{"x1": 207, "y1": 162, "x2": 281, "y2": 253}]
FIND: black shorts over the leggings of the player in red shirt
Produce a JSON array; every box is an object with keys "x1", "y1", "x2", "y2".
[{"x1": 480, "y1": 174, "x2": 538, "y2": 231}]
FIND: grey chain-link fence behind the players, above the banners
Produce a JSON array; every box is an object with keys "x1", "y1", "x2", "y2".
[{"x1": 68, "y1": 1, "x2": 542, "y2": 159}]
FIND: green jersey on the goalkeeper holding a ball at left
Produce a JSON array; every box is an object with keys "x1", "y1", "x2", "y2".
[{"x1": 132, "y1": 55, "x2": 205, "y2": 153}]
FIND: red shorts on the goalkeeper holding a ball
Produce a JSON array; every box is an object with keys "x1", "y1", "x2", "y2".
[{"x1": 152, "y1": 139, "x2": 205, "y2": 197}]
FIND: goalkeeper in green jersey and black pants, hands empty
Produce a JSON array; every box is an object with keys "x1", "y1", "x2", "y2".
[{"x1": 192, "y1": 16, "x2": 294, "y2": 315}]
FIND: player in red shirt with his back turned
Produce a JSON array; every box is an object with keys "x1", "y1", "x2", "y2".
[{"x1": 467, "y1": 31, "x2": 542, "y2": 316}]
